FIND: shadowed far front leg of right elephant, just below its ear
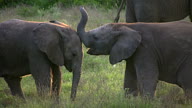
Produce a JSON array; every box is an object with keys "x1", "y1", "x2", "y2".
[{"x1": 124, "y1": 60, "x2": 138, "y2": 96}]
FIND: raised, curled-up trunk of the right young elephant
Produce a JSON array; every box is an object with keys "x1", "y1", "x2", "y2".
[{"x1": 77, "y1": 7, "x2": 89, "y2": 47}]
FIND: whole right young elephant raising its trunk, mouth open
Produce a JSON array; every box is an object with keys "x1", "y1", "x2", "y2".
[{"x1": 77, "y1": 8, "x2": 192, "y2": 97}]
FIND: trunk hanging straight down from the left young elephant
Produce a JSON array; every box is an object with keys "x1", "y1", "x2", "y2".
[{"x1": 71, "y1": 56, "x2": 82, "y2": 101}]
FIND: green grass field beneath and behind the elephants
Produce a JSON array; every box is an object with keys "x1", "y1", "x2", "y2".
[{"x1": 0, "y1": 5, "x2": 192, "y2": 108}]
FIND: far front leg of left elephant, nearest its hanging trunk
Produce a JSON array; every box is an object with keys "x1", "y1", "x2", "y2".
[{"x1": 51, "y1": 64, "x2": 61, "y2": 97}]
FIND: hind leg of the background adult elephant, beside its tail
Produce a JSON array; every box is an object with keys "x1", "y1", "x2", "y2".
[{"x1": 125, "y1": 0, "x2": 137, "y2": 23}]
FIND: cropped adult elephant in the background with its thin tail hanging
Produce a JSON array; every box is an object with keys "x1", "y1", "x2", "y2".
[{"x1": 114, "y1": 0, "x2": 192, "y2": 23}]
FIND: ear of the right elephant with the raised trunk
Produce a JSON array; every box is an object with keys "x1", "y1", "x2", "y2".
[{"x1": 109, "y1": 27, "x2": 141, "y2": 64}]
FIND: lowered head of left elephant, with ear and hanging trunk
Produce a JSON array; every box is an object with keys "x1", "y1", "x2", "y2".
[{"x1": 33, "y1": 23, "x2": 83, "y2": 100}]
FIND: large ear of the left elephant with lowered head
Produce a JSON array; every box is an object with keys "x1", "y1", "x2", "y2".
[{"x1": 33, "y1": 23, "x2": 64, "y2": 66}]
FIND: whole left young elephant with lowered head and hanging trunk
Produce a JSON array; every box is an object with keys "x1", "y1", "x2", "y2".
[{"x1": 0, "y1": 19, "x2": 83, "y2": 100}]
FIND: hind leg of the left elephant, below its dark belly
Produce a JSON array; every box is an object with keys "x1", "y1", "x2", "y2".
[{"x1": 4, "y1": 77, "x2": 25, "y2": 99}]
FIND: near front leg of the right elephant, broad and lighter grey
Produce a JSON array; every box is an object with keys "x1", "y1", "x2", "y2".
[{"x1": 136, "y1": 61, "x2": 158, "y2": 97}]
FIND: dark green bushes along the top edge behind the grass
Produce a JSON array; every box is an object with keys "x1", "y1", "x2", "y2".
[{"x1": 0, "y1": 0, "x2": 121, "y2": 9}]
